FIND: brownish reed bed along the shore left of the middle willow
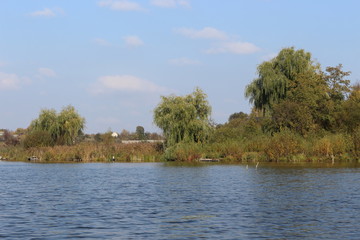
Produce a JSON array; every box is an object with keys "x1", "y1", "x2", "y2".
[{"x1": 0, "y1": 142, "x2": 162, "y2": 162}]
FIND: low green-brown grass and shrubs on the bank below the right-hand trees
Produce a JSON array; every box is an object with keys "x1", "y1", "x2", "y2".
[{"x1": 164, "y1": 131, "x2": 360, "y2": 163}]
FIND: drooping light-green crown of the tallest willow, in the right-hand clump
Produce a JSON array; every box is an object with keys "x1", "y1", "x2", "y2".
[{"x1": 245, "y1": 47, "x2": 319, "y2": 116}]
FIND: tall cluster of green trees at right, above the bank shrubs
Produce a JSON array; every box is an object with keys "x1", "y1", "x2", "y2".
[{"x1": 245, "y1": 48, "x2": 359, "y2": 136}]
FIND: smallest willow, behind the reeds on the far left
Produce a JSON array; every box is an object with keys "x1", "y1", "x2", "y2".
[{"x1": 29, "y1": 106, "x2": 85, "y2": 145}]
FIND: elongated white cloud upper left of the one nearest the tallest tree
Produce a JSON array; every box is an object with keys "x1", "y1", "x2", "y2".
[{"x1": 175, "y1": 27, "x2": 228, "y2": 40}]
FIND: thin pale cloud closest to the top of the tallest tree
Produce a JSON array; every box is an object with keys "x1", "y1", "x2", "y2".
[{"x1": 206, "y1": 41, "x2": 260, "y2": 54}]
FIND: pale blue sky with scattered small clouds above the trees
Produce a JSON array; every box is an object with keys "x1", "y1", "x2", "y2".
[{"x1": 0, "y1": 0, "x2": 360, "y2": 133}]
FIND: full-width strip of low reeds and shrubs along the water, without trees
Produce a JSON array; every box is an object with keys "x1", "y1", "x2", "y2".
[{"x1": 0, "y1": 129, "x2": 360, "y2": 163}]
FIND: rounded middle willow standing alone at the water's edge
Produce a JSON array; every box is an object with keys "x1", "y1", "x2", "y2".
[{"x1": 154, "y1": 88, "x2": 211, "y2": 146}]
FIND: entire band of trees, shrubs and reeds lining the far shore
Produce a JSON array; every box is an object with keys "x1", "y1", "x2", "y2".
[{"x1": 0, "y1": 47, "x2": 360, "y2": 164}]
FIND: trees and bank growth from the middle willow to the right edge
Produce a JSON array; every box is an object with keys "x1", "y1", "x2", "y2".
[{"x1": 154, "y1": 47, "x2": 360, "y2": 161}]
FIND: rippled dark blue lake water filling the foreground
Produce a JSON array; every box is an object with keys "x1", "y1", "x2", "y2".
[{"x1": 0, "y1": 162, "x2": 360, "y2": 239}]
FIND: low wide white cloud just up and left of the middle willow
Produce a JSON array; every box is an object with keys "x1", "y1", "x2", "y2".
[{"x1": 90, "y1": 75, "x2": 166, "y2": 94}]
